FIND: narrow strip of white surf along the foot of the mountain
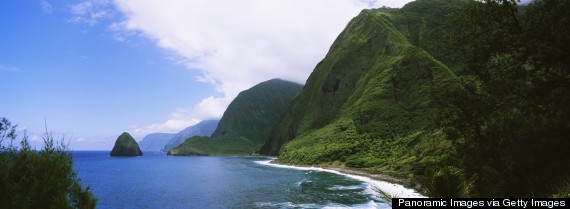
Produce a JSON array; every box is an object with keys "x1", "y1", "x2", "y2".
[{"x1": 256, "y1": 158, "x2": 426, "y2": 198}]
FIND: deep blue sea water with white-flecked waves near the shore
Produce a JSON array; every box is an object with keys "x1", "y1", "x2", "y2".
[{"x1": 72, "y1": 151, "x2": 390, "y2": 209}]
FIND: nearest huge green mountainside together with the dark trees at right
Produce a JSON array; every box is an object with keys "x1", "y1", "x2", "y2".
[{"x1": 260, "y1": 0, "x2": 570, "y2": 197}]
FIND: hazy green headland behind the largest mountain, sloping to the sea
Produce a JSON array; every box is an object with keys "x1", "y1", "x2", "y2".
[{"x1": 168, "y1": 79, "x2": 303, "y2": 155}]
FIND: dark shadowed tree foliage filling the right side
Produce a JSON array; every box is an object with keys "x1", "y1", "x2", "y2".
[{"x1": 434, "y1": 0, "x2": 570, "y2": 196}]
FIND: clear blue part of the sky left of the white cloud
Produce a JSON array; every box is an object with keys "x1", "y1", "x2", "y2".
[{"x1": 0, "y1": 1, "x2": 215, "y2": 149}]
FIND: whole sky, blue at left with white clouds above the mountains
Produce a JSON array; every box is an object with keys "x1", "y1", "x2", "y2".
[{"x1": 0, "y1": 0, "x2": 409, "y2": 150}]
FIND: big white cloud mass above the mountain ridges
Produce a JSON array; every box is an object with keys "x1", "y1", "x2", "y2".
[{"x1": 109, "y1": 0, "x2": 408, "y2": 136}]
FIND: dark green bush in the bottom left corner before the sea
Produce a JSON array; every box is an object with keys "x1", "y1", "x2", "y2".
[{"x1": 0, "y1": 118, "x2": 97, "y2": 209}]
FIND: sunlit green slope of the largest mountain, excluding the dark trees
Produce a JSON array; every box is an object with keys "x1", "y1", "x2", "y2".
[{"x1": 261, "y1": 3, "x2": 455, "y2": 183}]
